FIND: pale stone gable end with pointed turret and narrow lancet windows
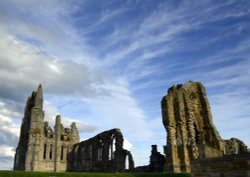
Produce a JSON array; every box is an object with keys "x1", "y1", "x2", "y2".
[{"x1": 14, "y1": 85, "x2": 79, "y2": 171}]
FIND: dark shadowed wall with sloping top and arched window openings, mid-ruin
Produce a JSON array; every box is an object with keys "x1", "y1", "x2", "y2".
[{"x1": 68, "y1": 129, "x2": 134, "y2": 172}]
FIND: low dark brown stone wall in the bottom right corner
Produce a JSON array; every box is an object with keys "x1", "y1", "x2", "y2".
[{"x1": 191, "y1": 154, "x2": 250, "y2": 177}]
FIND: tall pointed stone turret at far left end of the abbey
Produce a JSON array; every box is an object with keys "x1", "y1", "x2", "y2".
[{"x1": 14, "y1": 85, "x2": 44, "y2": 171}]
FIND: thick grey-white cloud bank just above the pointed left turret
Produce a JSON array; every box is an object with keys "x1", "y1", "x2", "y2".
[{"x1": 0, "y1": 32, "x2": 110, "y2": 100}]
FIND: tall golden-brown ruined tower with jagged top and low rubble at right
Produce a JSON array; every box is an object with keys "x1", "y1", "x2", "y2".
[{"x1": 161, "y1": 81, "x2": 247, "y2": 172}]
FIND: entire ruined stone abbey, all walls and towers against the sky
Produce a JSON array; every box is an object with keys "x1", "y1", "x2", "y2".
[{"x1": 14, "y1": 81, "x2": 250, "y2": 177}]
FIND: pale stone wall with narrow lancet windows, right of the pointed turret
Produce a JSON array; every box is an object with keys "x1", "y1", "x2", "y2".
[{"x1": 38, "y1": 116, "x2": 79, "y2": 172}]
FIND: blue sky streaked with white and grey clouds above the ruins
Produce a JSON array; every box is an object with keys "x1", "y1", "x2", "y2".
[{"x1": 0, "y1": 0, "x2": 250, "y2": 169}]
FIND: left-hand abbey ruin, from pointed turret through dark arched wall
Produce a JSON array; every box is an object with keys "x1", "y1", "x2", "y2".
[{"x1": 14, "y1": 85, "x2": 134, "y2": 172}]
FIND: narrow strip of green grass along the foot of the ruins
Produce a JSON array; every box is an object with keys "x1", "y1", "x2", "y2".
[{"x1": 0, "y1": 171, "x2": 191, "y2": 177}]
